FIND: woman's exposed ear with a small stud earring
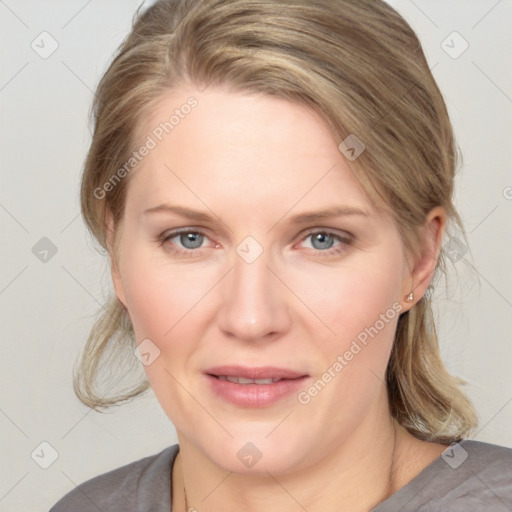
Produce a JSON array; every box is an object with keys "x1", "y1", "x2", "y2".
[{"x1": 402, "y1": 206, "x2": 446, "y2": 311}]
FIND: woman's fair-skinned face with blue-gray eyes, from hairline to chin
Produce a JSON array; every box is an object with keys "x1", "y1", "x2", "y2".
[{"x1": 113, "y1": 88, "x2": 422, "y2": 472}]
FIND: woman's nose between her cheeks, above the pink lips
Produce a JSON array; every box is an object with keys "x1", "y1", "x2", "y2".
[{"x1": 218, "y1": 246, "x2": 291, "y2": 341}]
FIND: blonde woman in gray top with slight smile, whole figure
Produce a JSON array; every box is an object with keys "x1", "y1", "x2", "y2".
[{"x1": 52, "y1": 0, "x2": 512, "y2": 512}]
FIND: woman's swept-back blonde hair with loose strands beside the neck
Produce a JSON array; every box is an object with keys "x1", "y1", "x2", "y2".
[{"x1": 75, "y1": 0, "x2": 477, "y2": 442}]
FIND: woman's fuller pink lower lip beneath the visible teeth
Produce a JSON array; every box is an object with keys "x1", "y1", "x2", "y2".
[{"x1": 206, "y1": 375, "x2": 308, "y2": 407}]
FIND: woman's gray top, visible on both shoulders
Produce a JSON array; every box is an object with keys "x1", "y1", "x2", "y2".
[{"x1": 50, "y1": 440, "x2": 512, "y2": 512}]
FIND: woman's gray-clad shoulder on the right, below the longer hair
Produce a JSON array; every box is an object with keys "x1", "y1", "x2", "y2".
[{"x1": 374, "y1": 439, "x2": 512, "y2": 512}]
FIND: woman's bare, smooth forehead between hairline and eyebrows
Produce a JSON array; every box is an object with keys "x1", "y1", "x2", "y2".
[{"x1": 128, "y1": 88, "x2": 372, "y2": 214}]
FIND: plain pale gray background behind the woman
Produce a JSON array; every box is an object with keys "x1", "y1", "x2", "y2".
[{"x1": 0, "y1": 0, "x2": 512, "y2": 511}]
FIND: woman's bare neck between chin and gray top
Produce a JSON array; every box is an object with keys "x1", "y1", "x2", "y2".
[{"x1": 172, "y1": 418, "x2": 428, "y2": 512}]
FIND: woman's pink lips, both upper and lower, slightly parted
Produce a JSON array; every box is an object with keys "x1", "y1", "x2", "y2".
[{"x1": 205, "y1": 366, "x2": 309, "y2": 408}]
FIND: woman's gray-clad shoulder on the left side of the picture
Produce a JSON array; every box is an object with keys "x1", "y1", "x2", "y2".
[{"x1": 50, "y1": 444, "x2": 179, "y2": 512}]
